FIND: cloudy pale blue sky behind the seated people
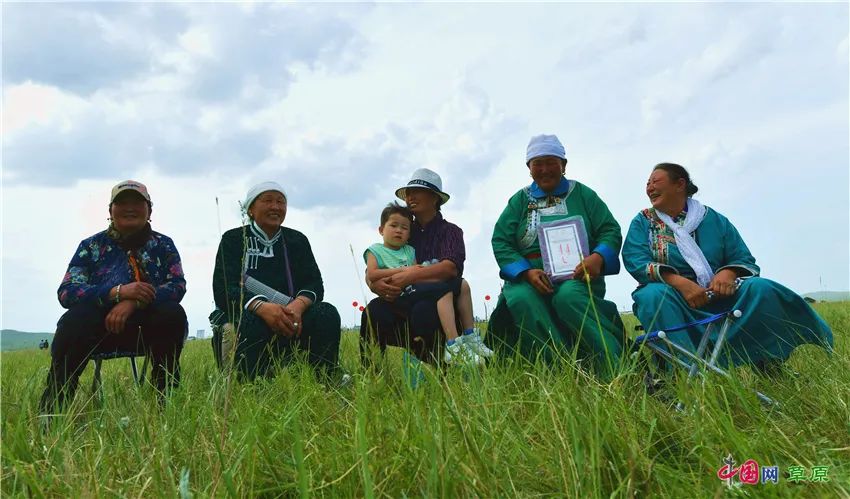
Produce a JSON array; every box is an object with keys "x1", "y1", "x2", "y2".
[{"x1": 2, "y1": 3, "x2": 850, "y2": 332}]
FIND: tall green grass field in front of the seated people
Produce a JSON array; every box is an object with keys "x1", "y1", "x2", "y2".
[{"x1": 0, "y1": 302, "x2": 850, "y2": 498}]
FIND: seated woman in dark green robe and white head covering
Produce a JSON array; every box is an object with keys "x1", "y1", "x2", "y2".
[{"x1": 210, "y1": 182, "x2": 340, "y2": 379}]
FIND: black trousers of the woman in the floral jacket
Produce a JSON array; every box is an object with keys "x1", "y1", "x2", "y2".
[{"x1": 40, "y1": 302, "x2": 186, "y2": 413}]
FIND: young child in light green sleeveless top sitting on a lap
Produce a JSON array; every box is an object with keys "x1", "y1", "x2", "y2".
[{"x1": 363, "y1": 203, "x2": 493, "y2": 365}]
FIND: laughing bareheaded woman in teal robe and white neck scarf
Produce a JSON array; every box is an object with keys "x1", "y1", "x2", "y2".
[{"x1": 623, "y1": 163, "x2": 832, "y2": 372}]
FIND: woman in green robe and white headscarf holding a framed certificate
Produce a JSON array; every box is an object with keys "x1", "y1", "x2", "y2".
[{"x1": 487, "y1": 135, "x2": 624, "y2": 375}]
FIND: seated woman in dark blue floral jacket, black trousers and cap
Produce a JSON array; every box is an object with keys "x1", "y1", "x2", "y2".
[{"x1": 40, "y1": 180, "x2": 186, "y2": 414}]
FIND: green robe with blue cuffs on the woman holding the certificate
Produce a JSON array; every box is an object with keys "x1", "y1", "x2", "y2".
[{"x1": 487, "y1": 177, "x2": 624, "y2": 373}]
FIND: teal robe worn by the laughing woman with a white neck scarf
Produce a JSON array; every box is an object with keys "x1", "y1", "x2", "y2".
[{"x1": 623, "y1": 207, "x2": 833, "y2": 365}]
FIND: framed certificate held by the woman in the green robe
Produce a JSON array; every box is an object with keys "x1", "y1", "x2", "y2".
[{"x1": 537, "y1": 217, "x2": 590, "y2": 282}]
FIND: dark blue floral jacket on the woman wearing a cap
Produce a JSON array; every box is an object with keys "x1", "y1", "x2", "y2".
[{"x1": 57, "y1": 231, "x2": 186, "y2": 308}]
